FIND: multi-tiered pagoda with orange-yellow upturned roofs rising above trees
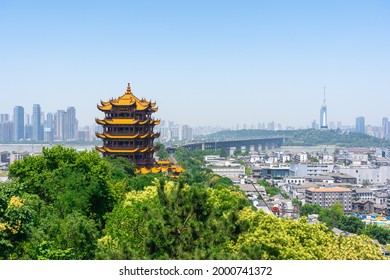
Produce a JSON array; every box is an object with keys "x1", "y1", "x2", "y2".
[{"x1": 96, "y1": 84, "x2": 183, "y2": 177}]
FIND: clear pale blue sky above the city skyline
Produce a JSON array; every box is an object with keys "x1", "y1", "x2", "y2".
[{"x1": 0, "y1": 0, "x2": 390, "y2": 127}]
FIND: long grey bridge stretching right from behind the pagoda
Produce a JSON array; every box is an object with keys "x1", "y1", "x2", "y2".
[{"x1": 166, "y1": 137, "x2": 285, "y2": 154}]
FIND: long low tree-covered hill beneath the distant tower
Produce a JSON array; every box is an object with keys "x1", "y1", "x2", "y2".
[{"x1": 201, "y1": 129, "x2": 390, "y2": 148}]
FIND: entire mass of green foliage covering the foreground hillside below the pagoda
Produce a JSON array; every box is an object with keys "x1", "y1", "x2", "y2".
[{"x1": 0, "y1": 146, "x2": 383, "y2": 260}]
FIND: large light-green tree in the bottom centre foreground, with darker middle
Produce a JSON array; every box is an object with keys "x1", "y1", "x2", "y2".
[{"x1": 98, "y1": 180, "x2": 249, "y2": 259}]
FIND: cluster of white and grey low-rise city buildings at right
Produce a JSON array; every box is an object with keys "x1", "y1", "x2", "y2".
[{"x1": 241, "y1": 148, "x2": 390, "y2": 215}]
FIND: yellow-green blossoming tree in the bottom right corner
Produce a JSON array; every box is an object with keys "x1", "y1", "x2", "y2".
[{"x1": 231, "y1": 208, "x2": 384, "y2": 260}]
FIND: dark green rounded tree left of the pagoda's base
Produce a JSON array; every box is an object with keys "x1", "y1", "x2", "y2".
[{"x1": 9, "y1": 145, "x2": 114, "y2": 225}]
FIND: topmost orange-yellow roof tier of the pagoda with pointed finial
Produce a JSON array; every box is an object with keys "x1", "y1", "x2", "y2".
[{"x1": 97, "y1": 84, "x2": 158, "y2": 112}]
